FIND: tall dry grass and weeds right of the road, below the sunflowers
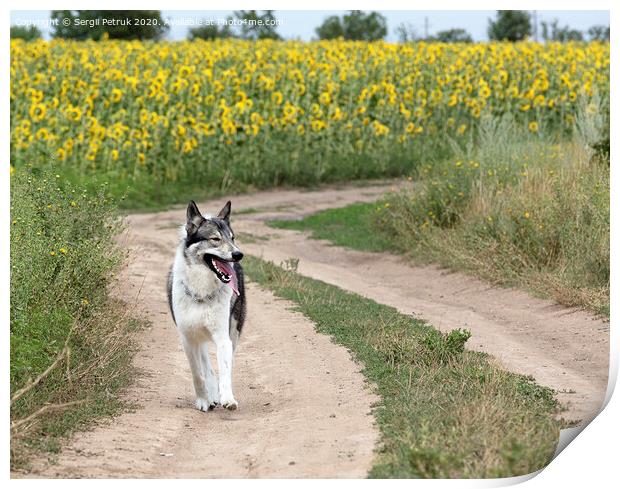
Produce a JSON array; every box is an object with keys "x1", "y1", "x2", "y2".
[{"x1": 271, "y1": 114, "x2": 610, "y2": 316}]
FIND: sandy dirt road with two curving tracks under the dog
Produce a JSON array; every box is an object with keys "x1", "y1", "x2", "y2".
[{"x1": 25, "y1": 185, "x2": 609, "y2": 477}]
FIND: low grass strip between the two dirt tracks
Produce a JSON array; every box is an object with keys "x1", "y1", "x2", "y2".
[{"x1": 244, "y1": 257, "x2": 560, "y2": 478}]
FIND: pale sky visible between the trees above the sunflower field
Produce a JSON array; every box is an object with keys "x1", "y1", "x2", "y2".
[{"x1": 11, "y1": 10, "x2": 609, "y2": 42}]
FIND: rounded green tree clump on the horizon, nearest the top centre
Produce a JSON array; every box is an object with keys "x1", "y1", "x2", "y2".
[{"x1": 315, "y1": 10, "x2": 387, "y2": 41}]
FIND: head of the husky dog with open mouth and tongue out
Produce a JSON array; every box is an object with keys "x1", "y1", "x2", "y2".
[{"x1": 184, "y1": 200, "x2": 243, "y2": 283}]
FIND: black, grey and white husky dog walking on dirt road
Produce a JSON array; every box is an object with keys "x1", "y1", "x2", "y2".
[{"x1": 168, "y1": 200, "x2": 246, "y2": 411}]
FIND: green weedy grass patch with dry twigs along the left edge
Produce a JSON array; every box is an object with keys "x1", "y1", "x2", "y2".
[{"x1": 10, "y1": 169, "x2": 139, "y2": 469}]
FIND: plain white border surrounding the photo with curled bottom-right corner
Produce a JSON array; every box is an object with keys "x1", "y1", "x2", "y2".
[{"x1": 0, "y1": 0, "x2": 620, "y2": 488}]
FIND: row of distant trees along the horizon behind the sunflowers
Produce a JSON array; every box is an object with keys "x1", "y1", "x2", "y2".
[{"x1": 11, "y1": 10, "x2": 610, "y2": 42}]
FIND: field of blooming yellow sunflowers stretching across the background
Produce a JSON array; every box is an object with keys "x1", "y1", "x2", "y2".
[{"x1": 10, "y1": 40, "x2": 609, "y2": 204}]
